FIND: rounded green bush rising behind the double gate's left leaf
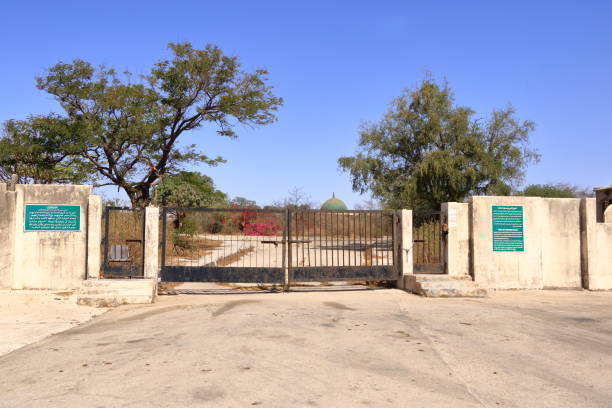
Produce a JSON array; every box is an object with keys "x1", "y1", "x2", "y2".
[{"x1": 153, "y1": 171, "x2": 227, "y2": 207}]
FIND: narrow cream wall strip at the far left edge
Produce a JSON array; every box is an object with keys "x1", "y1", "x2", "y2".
[{"x1": 0, "y1": 184, "x2": 15, "y2": 288}]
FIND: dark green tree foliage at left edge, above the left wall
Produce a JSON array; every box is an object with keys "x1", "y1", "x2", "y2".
[{"x1": 0, "y1": 115, "x2": 92, "y2": 184}]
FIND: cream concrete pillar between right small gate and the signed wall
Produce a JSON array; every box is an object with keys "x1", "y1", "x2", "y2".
[{"x1": 441, "y1": 203, "x2": 470, "y2": 275}]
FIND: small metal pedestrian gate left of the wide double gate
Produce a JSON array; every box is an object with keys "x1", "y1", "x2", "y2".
[{"x1": 102, "y1": 207, "x2": 145, "y2": 278}]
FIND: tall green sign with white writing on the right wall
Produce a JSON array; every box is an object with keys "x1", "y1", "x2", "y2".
[{"x1": 492, "y1": 205, "x2": 525, "y2": 252}]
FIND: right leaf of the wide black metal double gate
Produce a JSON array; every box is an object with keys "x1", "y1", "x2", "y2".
[{"x1": 288, "y1": 210, "x2": 399, "y2": 282}]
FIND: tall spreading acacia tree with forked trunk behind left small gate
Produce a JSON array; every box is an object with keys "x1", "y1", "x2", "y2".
[{"x1": 37, "y1": 43, "x2": 282, "y2": 206}]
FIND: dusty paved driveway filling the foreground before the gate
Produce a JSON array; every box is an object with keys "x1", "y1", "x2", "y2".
[{"x1": 0, "y1": 289, "x2": 612, "y2": 408}]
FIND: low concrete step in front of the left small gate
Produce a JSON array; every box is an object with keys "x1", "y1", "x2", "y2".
[{"x1": 77, "y1": 279, "x2": 157, "y2": 307}]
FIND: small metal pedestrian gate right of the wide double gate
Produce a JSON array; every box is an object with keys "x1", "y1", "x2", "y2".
[{"x1": 412, "y1": 210, "x2": 445, "y2": 273}]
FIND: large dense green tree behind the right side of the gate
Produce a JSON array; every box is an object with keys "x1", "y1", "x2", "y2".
[{"x1": 338, "y1": 78, "x2": 539, "y2": 208}]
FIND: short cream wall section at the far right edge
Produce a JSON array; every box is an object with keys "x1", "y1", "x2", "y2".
[{"x1": 582, "y1": 198, "x2": 612, "y2": 290}]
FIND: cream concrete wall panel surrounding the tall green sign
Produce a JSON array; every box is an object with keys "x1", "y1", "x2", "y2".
[{"x1": 470, "y1": 196, "x2": 584, "y2": 289}]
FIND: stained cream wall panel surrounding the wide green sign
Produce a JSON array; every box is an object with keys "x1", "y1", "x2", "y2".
[{"x1": 12, "y1": 185, "x2": 92, "y2": 289}]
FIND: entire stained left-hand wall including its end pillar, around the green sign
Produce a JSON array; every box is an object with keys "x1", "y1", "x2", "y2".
[{"x1": 0, "y1": 184, "x2": 101, "y2": 289}]
